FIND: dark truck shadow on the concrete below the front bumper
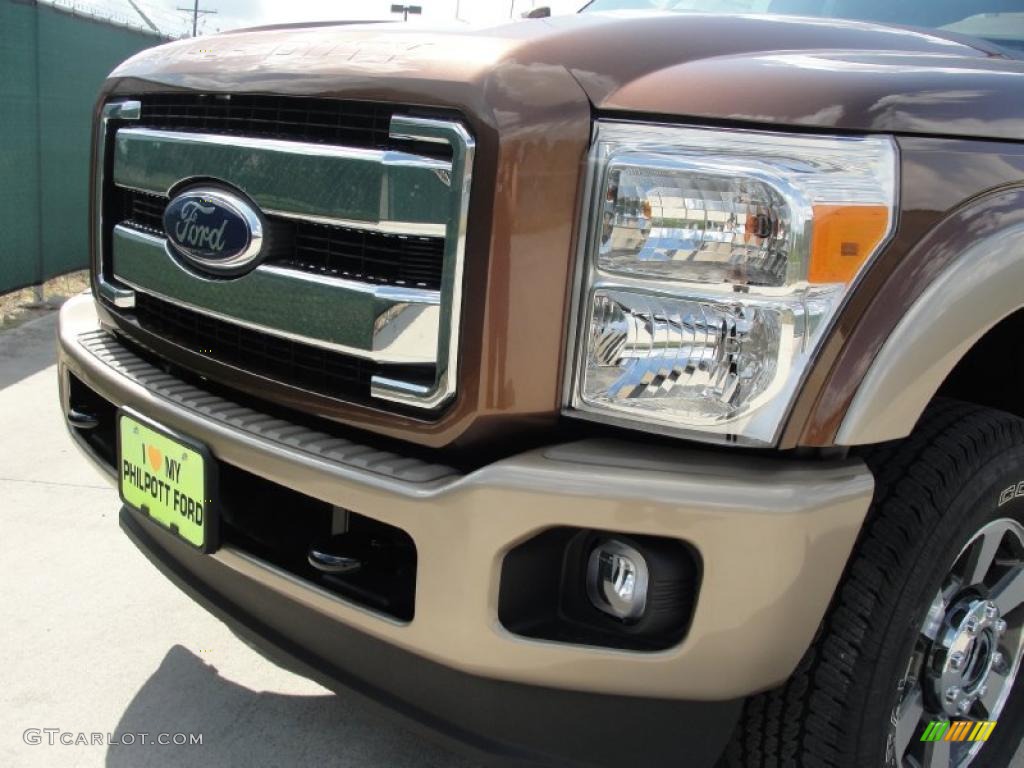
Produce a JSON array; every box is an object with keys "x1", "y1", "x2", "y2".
[{"x1": 106, "y1": 645, "x2": 473, "y2": 768}]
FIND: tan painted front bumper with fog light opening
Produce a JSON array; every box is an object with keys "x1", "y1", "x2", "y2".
[{"x1": 59, "y1": 296, "x2": 873, "y2": 700}]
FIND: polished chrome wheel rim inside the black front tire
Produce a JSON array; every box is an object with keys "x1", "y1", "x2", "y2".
[{"x1": 886, "y1": 518, "x2": 1024, "y2": 768}]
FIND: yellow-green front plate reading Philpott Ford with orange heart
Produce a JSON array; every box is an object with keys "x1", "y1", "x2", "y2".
[{"x1": 118, "y1": 411, "x2": 217, "y2": 552}]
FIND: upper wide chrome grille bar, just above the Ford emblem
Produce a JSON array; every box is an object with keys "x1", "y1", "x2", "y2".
[{"x1": 114, "y1": 128, "x2": 452, "y2": 234}]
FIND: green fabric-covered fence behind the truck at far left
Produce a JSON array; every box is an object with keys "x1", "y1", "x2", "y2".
[{"x1": 0, "y1": 0, "x2": 162, "y2": 294}]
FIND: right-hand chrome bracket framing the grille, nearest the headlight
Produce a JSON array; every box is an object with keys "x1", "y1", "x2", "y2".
[{"x1": 370, "y1": 115, "x2": 476, "y2": 410}]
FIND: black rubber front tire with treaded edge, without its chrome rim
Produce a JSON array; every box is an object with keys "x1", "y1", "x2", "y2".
[{"x1": 721, "y1": 400, "x2": 1024, "y2": 768}]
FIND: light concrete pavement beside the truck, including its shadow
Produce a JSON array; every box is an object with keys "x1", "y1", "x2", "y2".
[{"x1": 0, "y1": 315, "x2": 479, "y2": 768}]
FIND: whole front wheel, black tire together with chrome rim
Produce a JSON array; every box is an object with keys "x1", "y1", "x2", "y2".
[{"x1": 722, "y1": 400, "x2": 1024, "y2": 768}]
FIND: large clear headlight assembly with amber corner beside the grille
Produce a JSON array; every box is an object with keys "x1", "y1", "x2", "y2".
[{"x1": 566, "y1": 122, "x2": 897, "y2": 445}]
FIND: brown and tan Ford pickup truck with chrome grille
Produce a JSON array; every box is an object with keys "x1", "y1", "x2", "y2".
[{"x1": 59, "y1": 0, "x2": 1024, "y2": 768}]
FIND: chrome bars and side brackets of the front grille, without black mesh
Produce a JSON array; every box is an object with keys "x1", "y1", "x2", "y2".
[{"x1": 95, "y1": 101, "x2": 475, "y2": 410}]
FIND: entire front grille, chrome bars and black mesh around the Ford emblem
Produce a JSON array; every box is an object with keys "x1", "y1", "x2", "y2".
[{"x1": 96, "y1": 96, "x2": 474, "y2": 409}]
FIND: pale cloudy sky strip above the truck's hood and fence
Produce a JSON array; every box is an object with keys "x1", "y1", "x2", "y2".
[{"x1": 51, "y1": 0, "x2": 586, "y2": 37}]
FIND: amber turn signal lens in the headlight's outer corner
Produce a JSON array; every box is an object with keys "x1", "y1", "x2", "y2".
[{"x1": 807, "y1": 206, "x2": 889, "y2": 284}]
